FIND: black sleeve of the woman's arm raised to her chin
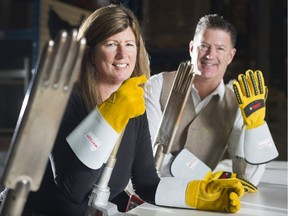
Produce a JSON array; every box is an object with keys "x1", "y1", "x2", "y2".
[{"x1": 50, "y1": 88, "x2": 101, "y2": 204}]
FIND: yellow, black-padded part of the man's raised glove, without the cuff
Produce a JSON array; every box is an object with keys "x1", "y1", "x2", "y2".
[{"x1": 232, "y1": 70, "x2": 268, "y2": 130}]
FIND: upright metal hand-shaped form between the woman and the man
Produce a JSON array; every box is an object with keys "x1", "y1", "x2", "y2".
[{"x1": 154, "y1": 62, "x2": 195, "y2": 173}]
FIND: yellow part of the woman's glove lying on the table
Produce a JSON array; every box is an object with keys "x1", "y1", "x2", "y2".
[{"x1": 186, "y1": 178, "x2": 244, "y2": 213}]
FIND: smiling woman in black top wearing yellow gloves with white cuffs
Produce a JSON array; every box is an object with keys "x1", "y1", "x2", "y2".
[{"x1": 7, "y1": 3, "x2": 244, "y2": 216}]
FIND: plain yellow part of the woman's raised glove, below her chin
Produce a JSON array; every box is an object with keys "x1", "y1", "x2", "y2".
[{"x1": 98, "y1": 75, "x2": 147, "y2": 133}]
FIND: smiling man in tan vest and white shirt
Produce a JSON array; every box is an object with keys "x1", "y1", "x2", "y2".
[{"x1": 145, "y1": 14, "x2": 278, "y2": 185}]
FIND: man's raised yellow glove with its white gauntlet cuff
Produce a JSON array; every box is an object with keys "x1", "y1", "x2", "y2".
[{"x1": 233, "y1": 70, "x2": 279, "y2": 164}]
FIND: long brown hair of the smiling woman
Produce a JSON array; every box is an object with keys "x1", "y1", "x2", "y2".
[{"x1": 77, "y1": 5, "x2": 150, "y2": 112}]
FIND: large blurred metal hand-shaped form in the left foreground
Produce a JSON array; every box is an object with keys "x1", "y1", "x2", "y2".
[{"x1": 0, "y1": 30, "x2": 86, "y2": 216}]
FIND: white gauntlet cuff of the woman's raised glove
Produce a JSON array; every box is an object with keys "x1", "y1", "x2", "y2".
[{"x1": 66, "y1": 108, "x2": 120, "y2": 169}]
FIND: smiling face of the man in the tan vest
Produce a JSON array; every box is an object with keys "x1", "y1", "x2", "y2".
[{"x1": 190, "y1": 29, "x2": 236, "y2": 81}]
